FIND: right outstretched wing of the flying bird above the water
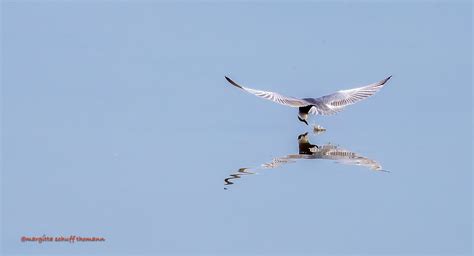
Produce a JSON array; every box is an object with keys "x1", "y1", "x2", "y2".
[{"x1": 304, "y1": 76, "x2": 392, "y2": 115}]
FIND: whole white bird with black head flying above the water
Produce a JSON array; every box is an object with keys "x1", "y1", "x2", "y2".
[{"x1": 225, "y1": 76, "x2": 392, "y2": 125}]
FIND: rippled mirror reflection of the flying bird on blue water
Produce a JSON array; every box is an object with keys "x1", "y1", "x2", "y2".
[{"x1": 224, "y1": 132, "x2": 386, "y2": 189}]
